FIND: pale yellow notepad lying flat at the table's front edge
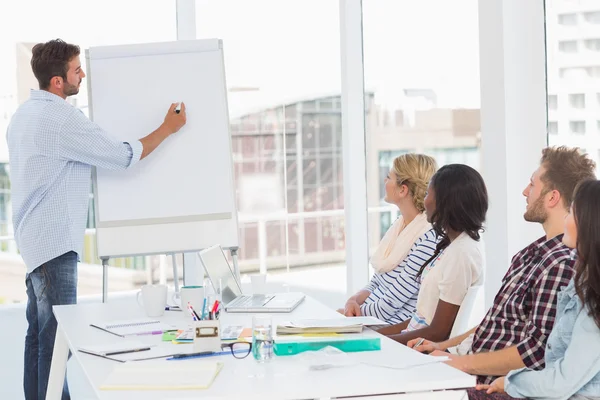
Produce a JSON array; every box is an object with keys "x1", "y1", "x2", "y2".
[{"x1": 100, "y1": 361, "x2": 223, "y2": 390}]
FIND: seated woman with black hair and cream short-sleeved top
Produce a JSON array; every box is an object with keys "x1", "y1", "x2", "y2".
[{"x1": 379, "y1": 164, "x2": 488, "y2": 344}]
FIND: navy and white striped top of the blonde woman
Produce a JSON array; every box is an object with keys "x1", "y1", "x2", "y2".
[{"x1": 360, "y1": 229, "x2": 438, "y2": 324}]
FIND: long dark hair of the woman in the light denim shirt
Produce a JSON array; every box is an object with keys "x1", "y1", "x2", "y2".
[{"x1": 573, "y1": 180, "x2": 600, "y2": 328}]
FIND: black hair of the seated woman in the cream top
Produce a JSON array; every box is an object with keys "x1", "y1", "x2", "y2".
[{"x1": 417, "y1": 164, "x2": 488, "y2": 276}]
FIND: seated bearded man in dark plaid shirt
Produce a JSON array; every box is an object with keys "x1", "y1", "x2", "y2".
[{"x1": 408, "y1": 147, "x2": 595, "y2": 390}]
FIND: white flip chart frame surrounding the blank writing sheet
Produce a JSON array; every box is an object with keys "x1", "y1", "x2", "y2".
[{"x1": 85, "y1": 39, "x2": 239, "y2": 259}]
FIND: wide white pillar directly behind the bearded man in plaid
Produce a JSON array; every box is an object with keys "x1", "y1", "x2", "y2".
[{"x1": 479, "y1": 0, "x2": 547, "y2": 306}]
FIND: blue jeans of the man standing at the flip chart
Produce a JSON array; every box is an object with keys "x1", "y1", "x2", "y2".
[{"x1": 23, "y1": 251, "x2": 77, "y2": 400}]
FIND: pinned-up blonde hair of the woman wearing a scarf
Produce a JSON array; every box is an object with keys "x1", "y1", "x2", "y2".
[{"x1": 392, "y1": 153, "x2": 437, "y2": 212}]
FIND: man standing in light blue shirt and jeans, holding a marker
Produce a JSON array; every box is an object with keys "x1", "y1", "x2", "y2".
[{"x1": 7, "y1": 39, "x2": 186, "y2": 400}]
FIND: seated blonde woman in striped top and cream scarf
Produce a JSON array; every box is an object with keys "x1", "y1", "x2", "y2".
[{"x1": 343, "y1": 154, "x2": 437, "y2": 324}]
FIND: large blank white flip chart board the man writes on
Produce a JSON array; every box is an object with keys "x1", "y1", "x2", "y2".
[{"x1": 86, "y1": 39, "x2": 239, "y2": 257}]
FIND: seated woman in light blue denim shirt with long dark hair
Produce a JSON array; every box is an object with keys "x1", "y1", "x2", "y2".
[{"x1": 470, "y1": 180, "x2": 600, "y2": 399}]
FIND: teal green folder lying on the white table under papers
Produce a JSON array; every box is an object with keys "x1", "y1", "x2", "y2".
[{"x1": 273, "y1": 337, "x2": 381, "y2": 356}]
